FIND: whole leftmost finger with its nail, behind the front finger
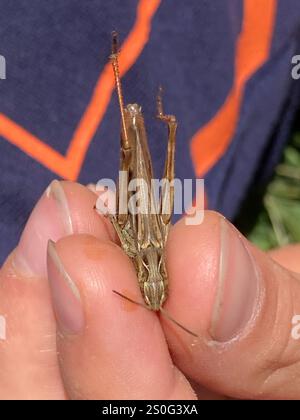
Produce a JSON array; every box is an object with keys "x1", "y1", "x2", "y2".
[{"x1": 0, "y1": 182, "x2": 115, "y2": 399}]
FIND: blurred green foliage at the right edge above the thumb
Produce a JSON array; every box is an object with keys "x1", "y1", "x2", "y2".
[{"x1": 236, "y1": 124, "x2": 300, "y2": 250}]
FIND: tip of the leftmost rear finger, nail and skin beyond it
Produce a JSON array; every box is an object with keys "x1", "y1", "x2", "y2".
[{"x1": 15, "y1": 180, "x2": 116, "y2": 278}]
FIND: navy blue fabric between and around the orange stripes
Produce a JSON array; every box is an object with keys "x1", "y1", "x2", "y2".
[{"x1": 0, "y1": 0, "x2": 300, "y2": 263}]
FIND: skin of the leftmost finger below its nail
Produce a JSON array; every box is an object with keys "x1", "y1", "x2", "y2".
[{"x1": 0, "y1": 255, "x2": 65, "y2": 400}]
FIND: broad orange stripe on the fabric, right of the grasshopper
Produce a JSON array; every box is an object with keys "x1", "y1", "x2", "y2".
[{"x1": 191, "y1": 0, "x2": 277, "y2": 177}]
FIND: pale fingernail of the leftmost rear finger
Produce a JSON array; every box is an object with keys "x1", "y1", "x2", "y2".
[{"x1": 13, "y1": 180, "x2": 73, "y2": 277}]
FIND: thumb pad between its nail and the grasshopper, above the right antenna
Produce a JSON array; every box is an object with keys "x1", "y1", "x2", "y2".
[{"x1": 166, "y1": 211, "x2": 222, "y2": 339}]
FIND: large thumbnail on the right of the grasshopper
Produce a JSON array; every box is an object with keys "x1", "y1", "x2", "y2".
[{"x1": 211, "y1": 219, "x2": 259, "y2": 342}]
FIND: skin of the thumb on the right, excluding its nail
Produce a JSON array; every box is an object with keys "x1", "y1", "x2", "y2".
[{"x1": 162, "y1": 212, "x2": 300, "y2": 399}]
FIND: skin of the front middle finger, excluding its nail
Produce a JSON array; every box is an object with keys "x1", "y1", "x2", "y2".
[{"x1": 48, "y1": 235, "x2": 195, "y2": 399}]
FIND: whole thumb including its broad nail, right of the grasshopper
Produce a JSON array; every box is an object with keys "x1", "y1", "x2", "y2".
[{"x1": 164, "y1": 212, "x2": 300, "y2": 399}]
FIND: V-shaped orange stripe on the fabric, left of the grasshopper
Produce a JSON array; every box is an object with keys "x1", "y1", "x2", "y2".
[{"x1": 0, "y1": 0, "x2": 161, "y2": 180}]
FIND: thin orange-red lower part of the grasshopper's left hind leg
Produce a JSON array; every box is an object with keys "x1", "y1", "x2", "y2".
[{"x1": 109, "y1": 31, "x2": 130, "y2": 149}]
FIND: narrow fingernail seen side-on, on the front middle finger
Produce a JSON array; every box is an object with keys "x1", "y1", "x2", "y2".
[{"x1": 47, "y1": 240, "x2": 84, "y2": 334}]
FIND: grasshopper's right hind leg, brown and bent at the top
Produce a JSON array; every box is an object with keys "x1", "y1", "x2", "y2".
[{"x1": 157, "y1": 87, "x2": 177, "y2": 226}]
